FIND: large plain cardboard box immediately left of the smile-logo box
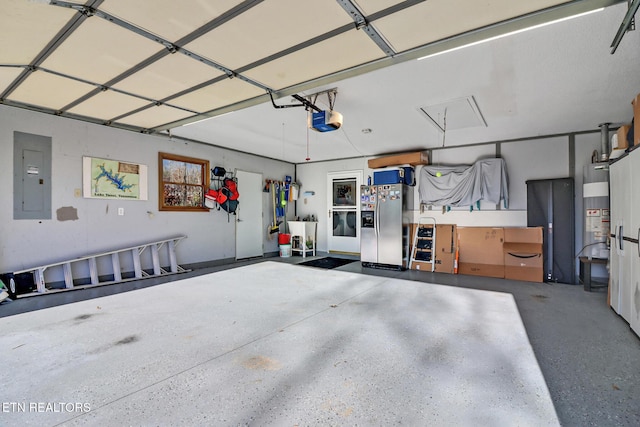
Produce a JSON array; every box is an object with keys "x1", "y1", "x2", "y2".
[{"x1": 458, "y1": 227, "x2": 504, "y2": 278}]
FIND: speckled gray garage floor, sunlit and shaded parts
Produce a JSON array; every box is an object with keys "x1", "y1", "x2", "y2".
[{"x1": 0, "y1": 257, "x2": 640, "y2": 426}]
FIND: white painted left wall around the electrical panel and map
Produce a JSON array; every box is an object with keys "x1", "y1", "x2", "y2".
[{"x1": 0, "y1": 105, "x2": 295, "y2": 277}]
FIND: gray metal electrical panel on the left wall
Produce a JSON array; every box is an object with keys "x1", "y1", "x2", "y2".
[{"x1": 13, "y1": 131, "x2": 51, "y2": 219}]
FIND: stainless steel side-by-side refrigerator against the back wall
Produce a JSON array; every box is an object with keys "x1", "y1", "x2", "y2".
[{"x1": 360, "y1": 184, "x2": 413, "y2": 269}]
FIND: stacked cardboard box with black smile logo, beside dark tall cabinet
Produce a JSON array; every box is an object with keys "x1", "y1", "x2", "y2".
[{"x1": 503, "y1": 227, "x2": 543, "y2": 282}]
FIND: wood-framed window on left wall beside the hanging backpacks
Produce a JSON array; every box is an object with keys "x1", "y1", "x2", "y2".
[{"x1": 158, "y1": 153, "x2": 210, "y2": 212}]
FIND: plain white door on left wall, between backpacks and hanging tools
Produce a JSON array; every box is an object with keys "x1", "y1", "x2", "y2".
[{"x1": 236, "y1": 170, "x2": 265, "y2": 260}]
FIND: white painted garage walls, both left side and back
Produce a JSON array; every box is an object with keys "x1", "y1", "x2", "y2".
[{"x1": 0, "y1": 105, "x2": 600, "y2": 284}]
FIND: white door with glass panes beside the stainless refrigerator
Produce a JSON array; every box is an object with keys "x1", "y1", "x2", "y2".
[{"x1": 327, "y1": 170, "x2": 362, "y2": 254}]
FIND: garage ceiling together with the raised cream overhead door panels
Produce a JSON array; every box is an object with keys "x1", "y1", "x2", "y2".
[{"x1": 0, "y1": 0, "x2": 640, "y2": 163}]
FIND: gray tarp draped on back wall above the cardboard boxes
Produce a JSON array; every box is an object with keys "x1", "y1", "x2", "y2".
[{"x1": 419, "y1": 159, "x2": 509, "y2": 208}]
